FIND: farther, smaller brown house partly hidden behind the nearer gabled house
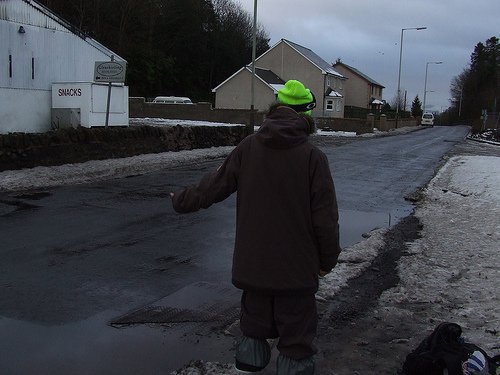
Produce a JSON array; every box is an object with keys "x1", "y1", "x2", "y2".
[{"x1": 333, "y1": 61, "x2": 385, "y2": 110}]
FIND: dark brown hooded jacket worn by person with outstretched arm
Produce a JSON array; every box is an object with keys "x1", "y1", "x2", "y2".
[{"x1": 172, "y1": 106, "x2": 341, "y2": 294}]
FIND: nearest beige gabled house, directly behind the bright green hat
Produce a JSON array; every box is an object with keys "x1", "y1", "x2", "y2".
[{"x1": 212, "y1": 39, "x2": 346, "y2": 117}]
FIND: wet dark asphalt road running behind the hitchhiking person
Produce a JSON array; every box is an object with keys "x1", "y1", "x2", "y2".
[{"x1": 0, "y1": 127, "x2": 468, "y2": 374}]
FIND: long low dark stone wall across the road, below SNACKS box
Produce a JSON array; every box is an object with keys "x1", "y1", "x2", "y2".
[{"x1": 0, "y1": 125, "x2": 246, "y2": 171}]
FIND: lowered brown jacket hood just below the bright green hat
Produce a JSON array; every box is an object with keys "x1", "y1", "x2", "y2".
[{"x1": 255, "y1": 106, "x2": 309, "y2": 149}]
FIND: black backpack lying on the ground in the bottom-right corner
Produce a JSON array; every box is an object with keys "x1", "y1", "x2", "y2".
[{"x1": 401, "y1": 323, "x2": 500, "y2": 375}]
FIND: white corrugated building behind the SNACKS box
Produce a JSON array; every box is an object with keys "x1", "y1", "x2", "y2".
[{"x1": 0, "y1": 0, "x2": 128, "y2": 134}]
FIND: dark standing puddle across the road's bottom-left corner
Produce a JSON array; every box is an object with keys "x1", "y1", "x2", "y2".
[{"x1": 0, "y1": 311, "x2": 236, "y2": 375}]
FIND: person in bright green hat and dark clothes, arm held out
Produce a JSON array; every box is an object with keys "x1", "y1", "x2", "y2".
[{"x1": 170, "y1": 80, "x2": 341, "y2": 375}]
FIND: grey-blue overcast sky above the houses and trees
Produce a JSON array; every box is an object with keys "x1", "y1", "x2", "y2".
[{"x1": 236, "y1": 0, "x2": 500, "y2": 111}]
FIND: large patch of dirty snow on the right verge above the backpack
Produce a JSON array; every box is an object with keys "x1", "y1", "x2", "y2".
[{"x1": 380, "y1": 156, "x2": 500, "y2": 354}]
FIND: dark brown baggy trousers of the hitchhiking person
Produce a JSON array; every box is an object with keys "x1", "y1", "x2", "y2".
[{"x1": 240, "y1": 291, "x2": 318, "y2": 360}]
